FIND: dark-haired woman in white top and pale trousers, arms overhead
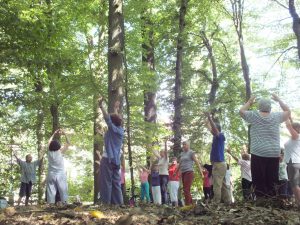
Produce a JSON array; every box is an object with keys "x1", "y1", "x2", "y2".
[{"x1": 47, "y1": 129, "x2": 70, "y2": 204}]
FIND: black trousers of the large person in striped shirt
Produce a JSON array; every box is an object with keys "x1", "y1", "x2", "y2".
[{"x1": 251, "y1": 154, "x2": 279, "y2": 197}]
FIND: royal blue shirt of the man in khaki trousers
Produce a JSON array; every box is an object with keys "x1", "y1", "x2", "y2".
[{"x1": 210, "y1": 133, "x2": 225, "y2": 162}]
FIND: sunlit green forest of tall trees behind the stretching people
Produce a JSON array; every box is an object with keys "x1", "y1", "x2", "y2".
[{"x1": 0, "y1": 0, "x2": 300, "y2": 224}]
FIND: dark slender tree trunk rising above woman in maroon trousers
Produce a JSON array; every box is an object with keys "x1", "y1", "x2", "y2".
[{"x1": 173, "y1": 0, "x2": 188, "y2": 156}]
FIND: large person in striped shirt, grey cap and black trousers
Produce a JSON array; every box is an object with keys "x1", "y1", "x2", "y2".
[{"x1": 240, "y1": 94, "x2": 291, "y2": 198}]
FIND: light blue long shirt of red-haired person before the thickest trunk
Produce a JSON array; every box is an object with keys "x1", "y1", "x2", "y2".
[{"x1": 104, "y1": 116, "x2": 124, "y2": 166}]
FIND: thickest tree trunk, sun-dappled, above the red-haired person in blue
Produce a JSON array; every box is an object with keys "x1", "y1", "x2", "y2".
[{"x1": 108, "y1": 0, "x2": 124, "y2": 113}]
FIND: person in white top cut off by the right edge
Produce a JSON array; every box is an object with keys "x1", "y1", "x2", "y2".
[{"x1": 284, "y1": 120, "x2": 300, "y2": 206}]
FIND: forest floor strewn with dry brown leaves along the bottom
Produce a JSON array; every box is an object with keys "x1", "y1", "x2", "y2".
[{"x1": 0, "y1": 201, "x2": 300, "y2": 225}]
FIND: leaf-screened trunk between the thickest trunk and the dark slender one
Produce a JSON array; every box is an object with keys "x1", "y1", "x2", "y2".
[{"x1": 141, "y1": 9, "x2": 157, "y2": 166}]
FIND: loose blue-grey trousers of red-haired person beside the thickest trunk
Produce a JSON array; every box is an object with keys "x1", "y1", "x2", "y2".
[{"x1": 99, "y1": 157, "x2": 123, "y2": 205}]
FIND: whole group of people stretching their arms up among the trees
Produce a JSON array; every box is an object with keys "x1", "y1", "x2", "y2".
[{"x1": 14, "y1": 94, "x2": 300, "y2": 206}]
